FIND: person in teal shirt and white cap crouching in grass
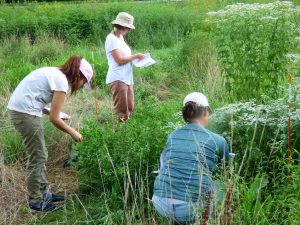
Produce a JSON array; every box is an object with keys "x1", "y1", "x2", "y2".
[{"x1": 152, "y1": 92, "x2": 229, "y2": 224}]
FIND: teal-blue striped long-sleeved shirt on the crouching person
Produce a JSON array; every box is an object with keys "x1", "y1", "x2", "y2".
[{"x1": 154, "y1": 123, "x2": 229, "y2": 202}]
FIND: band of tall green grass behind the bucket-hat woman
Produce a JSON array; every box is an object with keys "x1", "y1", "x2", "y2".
[{"x1": 0, "y1": 2, "x2": 196, "y2": 49}]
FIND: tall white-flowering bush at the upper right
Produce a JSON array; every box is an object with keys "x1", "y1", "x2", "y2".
[{"x1": 208, "y1": 2, "x2": 300, "y2": 101}]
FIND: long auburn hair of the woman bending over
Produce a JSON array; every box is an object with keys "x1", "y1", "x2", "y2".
[{"x1": 58, "y1": 55, "x2": 84, "y2": 95}]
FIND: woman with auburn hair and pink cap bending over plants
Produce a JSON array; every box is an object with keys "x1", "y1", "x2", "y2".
[{"x1": 7, "y1": 56, "x2": 93, "y2": 212}]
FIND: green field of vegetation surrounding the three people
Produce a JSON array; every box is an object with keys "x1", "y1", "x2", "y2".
[{"x1": 0, "y1": 0, "x2": 300, "y2": 225}]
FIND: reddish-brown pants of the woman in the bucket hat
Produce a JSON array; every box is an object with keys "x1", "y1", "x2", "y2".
[{"x1": 109, "y1": 81, "x2": 134, "y2": 121}]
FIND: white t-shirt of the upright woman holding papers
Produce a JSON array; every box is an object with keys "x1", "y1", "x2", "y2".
[{"x1": 105, "y1": 33, "x2": 133, "y2": 85}]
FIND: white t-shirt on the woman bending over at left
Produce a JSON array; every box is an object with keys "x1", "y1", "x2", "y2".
[{"x1": 7, "y1": 67, "x2": 69, "y2": 117}]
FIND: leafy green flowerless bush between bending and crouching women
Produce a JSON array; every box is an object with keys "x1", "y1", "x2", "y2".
[{"x1": 74, "y1": 97, "x2": 178, "y2": 193}]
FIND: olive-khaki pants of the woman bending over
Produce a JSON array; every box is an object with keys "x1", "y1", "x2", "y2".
[{"x1": 10, "y1": 111, "x2": 48, "y2": 203}]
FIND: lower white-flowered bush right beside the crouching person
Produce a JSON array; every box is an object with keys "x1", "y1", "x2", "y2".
[{"x1": 210, "y1": 80, "x2": 300, "y2": 183}]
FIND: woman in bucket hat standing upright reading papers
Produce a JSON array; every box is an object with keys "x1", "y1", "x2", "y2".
[{"x1": 105, "y1": 12, "x2": 145, "y2": 122}]
